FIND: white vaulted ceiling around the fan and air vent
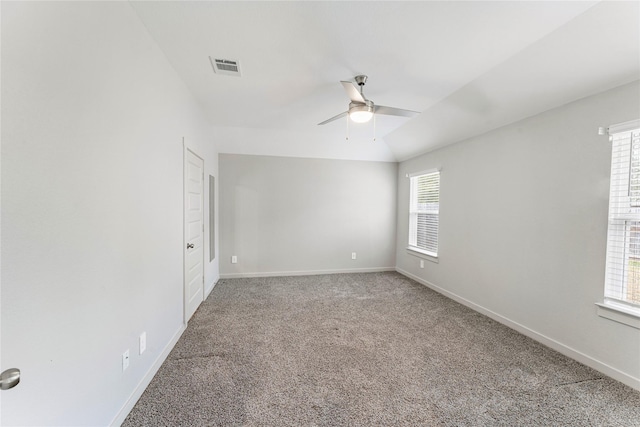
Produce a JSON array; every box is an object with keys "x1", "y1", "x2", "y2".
[{"x1": 130, "y1": 1, "x2": 640, "y2": 161}]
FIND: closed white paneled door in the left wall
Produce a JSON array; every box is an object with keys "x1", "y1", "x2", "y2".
[{"x1": 184, "y1": 149, "x2": 204, "y2": 323}]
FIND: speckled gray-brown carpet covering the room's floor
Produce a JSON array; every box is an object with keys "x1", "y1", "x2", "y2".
[{"x1": 123, "y1": 273, "x2": 640, "y2": 427}]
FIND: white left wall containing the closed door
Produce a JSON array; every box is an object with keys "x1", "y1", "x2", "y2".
[{"x1": 1, "y1": 2, "x2": 218, "y2": 426}]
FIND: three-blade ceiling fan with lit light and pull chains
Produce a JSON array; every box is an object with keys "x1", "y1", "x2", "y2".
[{"x1": 318, "y1": 75, "x2": 420, "y2": 125}]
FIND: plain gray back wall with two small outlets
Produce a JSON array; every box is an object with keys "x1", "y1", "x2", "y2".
[{"x1": 219, "y1": 154, "x2": 397, "y2": 277}]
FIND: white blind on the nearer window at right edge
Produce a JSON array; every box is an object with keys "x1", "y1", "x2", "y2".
[{"x1": 604, "y1": 128, "x2": 640, "y2": 309}]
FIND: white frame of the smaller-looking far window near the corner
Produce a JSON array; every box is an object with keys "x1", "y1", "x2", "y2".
[{"x1": 407, "y1": 169, "x2": 441, "y2": 263}]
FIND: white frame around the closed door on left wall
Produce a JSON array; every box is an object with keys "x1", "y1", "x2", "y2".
[{"x1": 182, "y1": 143, "x2": 205, "y2": 327}]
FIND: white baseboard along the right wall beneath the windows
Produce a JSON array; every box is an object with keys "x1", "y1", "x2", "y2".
[{"x1": 396, "y1": 268, "x2": 640, "y2": 391}]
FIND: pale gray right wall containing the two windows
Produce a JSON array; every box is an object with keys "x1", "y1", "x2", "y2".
[{"x1": 396, "y1": 82, "x2": 640, "y2": 387}]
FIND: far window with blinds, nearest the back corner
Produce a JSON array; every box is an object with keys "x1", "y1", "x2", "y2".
[{"x1": 409, "y1": 172, "x2": 440, "y2": 257}]
